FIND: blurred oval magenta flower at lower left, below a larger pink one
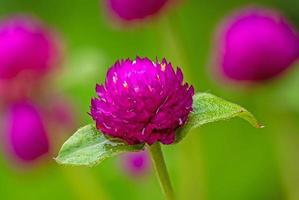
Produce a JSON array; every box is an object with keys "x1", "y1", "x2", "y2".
[{"x1": 4, "y1": 102, "x2": 49, "y2": 162}]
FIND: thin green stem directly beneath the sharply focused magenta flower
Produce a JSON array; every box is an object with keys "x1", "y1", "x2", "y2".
[{"x1": 149, "y1": 142, "x2": 175, "y2": 200}]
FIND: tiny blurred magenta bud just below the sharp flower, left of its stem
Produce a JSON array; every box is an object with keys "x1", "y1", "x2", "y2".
[{"x1": 121, "y1": 151, "x2": 151, "y2": 177}]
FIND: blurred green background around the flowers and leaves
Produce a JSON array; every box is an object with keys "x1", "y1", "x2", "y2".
[{"x1": 0, "y1": 0, "x2": 299, "y2": 200}]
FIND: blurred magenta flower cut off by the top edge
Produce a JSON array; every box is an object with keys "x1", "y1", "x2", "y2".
[{"x1": 107, "y1": 0, "x2": 169, "y2": 21}]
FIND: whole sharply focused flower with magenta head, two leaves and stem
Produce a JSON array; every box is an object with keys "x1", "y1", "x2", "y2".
[{"x1": 55, "y1": 57, "x2": 262, "y2": 199}]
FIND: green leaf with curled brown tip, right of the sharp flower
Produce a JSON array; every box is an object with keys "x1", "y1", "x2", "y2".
[{"x1": 176, "y1": 93, "x2": 262, "y2": 143}]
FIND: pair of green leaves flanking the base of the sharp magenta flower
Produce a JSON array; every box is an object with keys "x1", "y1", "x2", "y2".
[{"x1": 55, "y1": 93, "x2": 261, "y2": 166}]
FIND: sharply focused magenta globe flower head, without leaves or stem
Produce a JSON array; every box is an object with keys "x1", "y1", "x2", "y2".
[{"x1": 90, "y1": 57, "x2": 194, "y2": 145}]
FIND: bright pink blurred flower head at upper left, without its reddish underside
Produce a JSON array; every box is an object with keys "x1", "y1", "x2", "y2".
[{"x1": 0, "y1": 17, "x2": 58, "y2": 79}]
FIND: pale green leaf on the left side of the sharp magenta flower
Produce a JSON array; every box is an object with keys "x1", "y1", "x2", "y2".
[{"x1": 55, "y1": 125, "x2": 144, "y2": 166}]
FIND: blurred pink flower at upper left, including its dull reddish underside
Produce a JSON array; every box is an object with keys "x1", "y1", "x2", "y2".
[{"x1": 0, "y1": 16, "x2": 60, "y2": 99}]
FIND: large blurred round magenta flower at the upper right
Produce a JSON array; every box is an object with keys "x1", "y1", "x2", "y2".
[{"x1": 217, "y1": 8, "x2": 299, "y2": 82}]
